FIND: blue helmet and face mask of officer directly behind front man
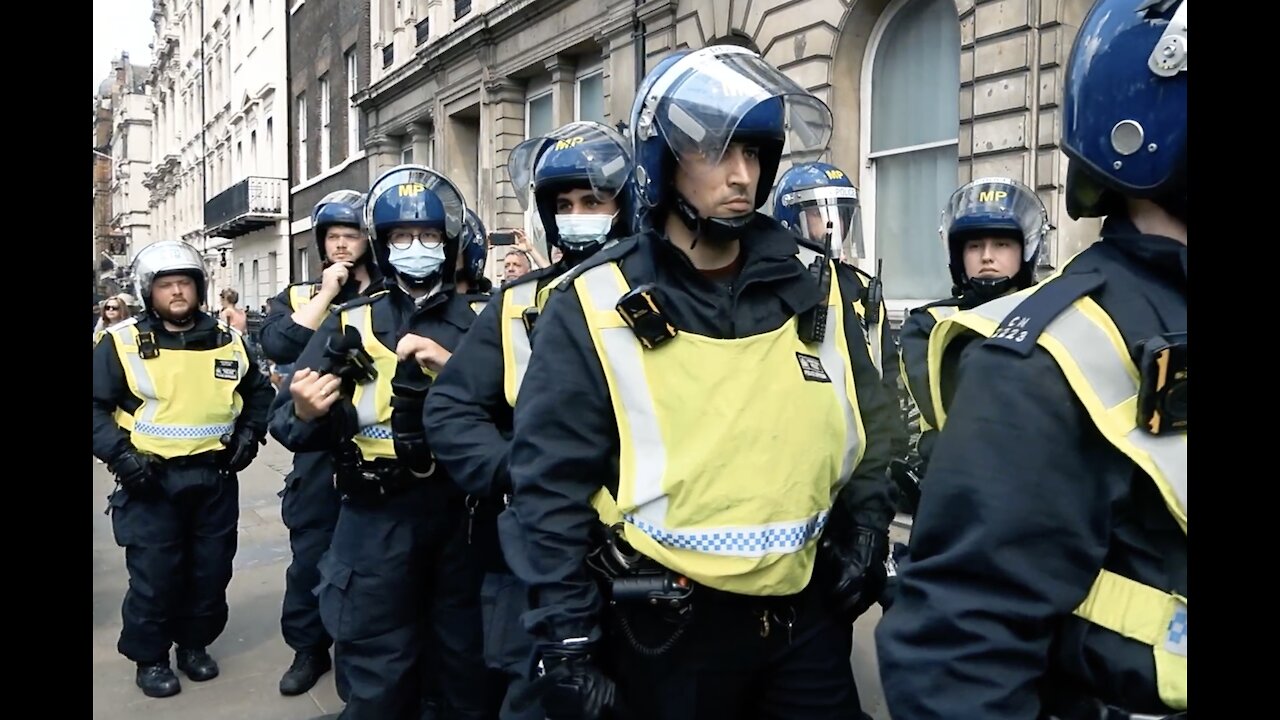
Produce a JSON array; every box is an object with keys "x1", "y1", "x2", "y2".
[{"x1": 507, "y1": 122, "x2": 632, "y2": 255}]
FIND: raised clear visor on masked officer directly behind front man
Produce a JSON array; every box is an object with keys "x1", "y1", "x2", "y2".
[{"x1": 507, "y1": 122, "x2": 631, "y2": 210}]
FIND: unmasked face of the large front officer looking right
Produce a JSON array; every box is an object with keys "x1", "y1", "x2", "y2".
[{"x1": 676, "y1": 142, "x2": 760, "y2": 218}]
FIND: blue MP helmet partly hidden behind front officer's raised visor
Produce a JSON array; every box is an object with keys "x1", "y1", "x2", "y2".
[{"x1": 773, "y1": 163, "x2": 865, "y2": 260}]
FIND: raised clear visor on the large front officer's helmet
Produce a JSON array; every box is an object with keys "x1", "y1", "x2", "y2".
[{"x1": 636, "y1": 46, "x2": 832, "y2": 165}]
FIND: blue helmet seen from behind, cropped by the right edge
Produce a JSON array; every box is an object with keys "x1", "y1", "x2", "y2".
[{"x1": 1062, "y1": 0, "x2": 1188, "y2": 223}]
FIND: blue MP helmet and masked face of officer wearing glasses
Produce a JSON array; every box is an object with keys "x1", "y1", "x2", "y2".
[{"x1": 365, "y1": 164, "x2": 467, "y2": 287}]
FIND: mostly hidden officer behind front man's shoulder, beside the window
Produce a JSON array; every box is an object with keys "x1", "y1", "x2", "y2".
[{"x1": 773, "y1": 163, "x2": 909, "y2": 459}]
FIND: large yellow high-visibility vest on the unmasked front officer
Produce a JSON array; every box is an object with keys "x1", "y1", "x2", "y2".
[{"x1": 575, "y1": 263, "x2": 865, "y2": 596}]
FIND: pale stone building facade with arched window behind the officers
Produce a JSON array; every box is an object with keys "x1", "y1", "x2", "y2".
[{"x1": 357, "y1": 0, "x2": 1097, "y2": 318}]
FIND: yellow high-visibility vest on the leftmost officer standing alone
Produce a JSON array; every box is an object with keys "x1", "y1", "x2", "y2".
[{"x1": 106, "y1": 322, "x2": 250, "y2": 459}]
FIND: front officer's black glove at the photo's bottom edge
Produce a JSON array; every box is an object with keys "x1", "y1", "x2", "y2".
[{"x1": 541, "y1": 641, "x2": 617, "y2": 720}]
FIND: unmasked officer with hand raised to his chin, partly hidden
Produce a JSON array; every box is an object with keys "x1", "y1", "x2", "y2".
[{"x1": 261, "y1": 190, "x2": 380, "y2": 696}]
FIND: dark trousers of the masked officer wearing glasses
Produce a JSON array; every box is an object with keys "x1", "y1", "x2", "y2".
[{"x1": 317, "y1": 479, "x2": 489, "y2": 720}]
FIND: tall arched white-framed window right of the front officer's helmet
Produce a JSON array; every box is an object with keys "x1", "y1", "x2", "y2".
[{"x1": 861, "y1": 0, "x2": 960, "y2": 301}]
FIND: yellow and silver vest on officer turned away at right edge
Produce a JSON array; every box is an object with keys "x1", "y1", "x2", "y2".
[{"x1": 929, "y1": 281, "x2": 1187, "y2": 710}]
